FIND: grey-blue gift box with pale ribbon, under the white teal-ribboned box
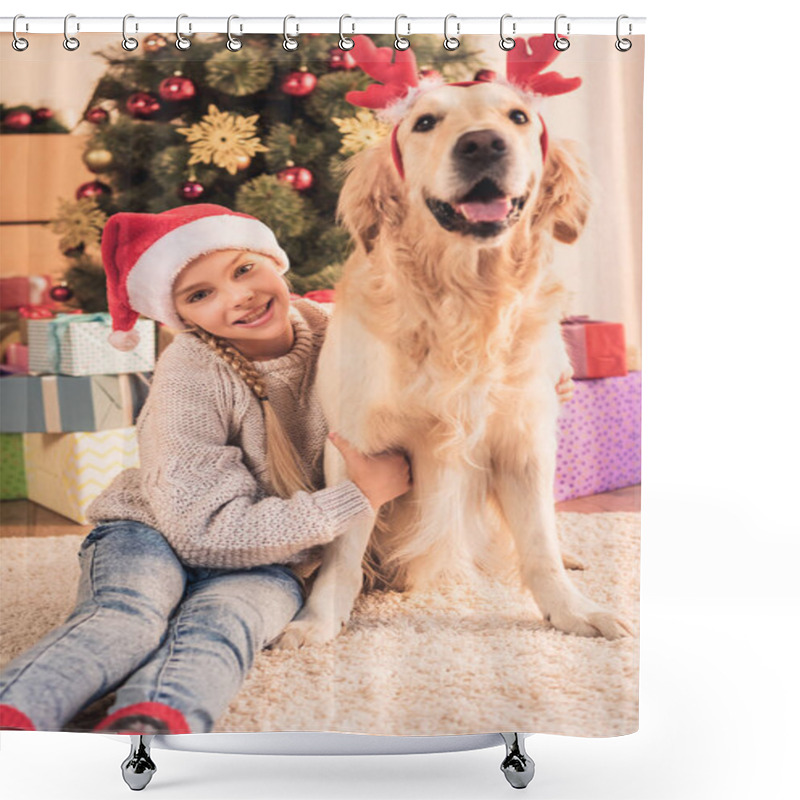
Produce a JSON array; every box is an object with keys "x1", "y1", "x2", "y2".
[{"x1": 0, "y1": 373, "x2": 152, "y2": 433}]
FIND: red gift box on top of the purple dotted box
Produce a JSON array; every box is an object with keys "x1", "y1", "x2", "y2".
[{"x1": 561, "y1": 316, "x2": 628, "y2": 378}]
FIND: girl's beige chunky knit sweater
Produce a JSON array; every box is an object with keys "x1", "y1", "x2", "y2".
[{"x1": 88, "y1": 299, "x2": 372, "y2": 576}]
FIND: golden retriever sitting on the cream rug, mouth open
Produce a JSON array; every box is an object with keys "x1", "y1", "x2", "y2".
[{"x1": 276, "y1": 40, "x2": 631, "y2": 649}]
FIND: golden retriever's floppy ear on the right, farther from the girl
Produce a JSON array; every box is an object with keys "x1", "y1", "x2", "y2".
[{"x1": 533, "y1": 140, "x2": 590, "y2": 244}]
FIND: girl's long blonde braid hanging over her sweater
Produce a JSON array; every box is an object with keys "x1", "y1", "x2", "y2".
[{"x1": 186, "y1": 325, "x2": 313, "y2": 499}]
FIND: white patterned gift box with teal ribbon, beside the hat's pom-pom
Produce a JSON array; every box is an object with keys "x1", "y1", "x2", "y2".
[{"x1": 28, "y1": 313, "x2": 156, "y2": 375}]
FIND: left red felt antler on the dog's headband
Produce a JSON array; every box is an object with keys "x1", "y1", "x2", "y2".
[{"x1": 345, "y1": 35, "x2": 419, "y2": 108}]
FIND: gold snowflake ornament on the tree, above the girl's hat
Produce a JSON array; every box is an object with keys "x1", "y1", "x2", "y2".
[{"x1": 178, "y1": 105, "x2": 267, "y2": 175}]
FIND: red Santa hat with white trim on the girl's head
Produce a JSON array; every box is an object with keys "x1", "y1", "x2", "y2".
[{"x1": 101, "y1": 203, "x2": 289, "y2": 350}]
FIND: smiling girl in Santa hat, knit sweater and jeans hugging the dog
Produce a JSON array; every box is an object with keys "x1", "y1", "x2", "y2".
[{"x1": 0, "y1": 204, "x2": 410, "y2": 734}]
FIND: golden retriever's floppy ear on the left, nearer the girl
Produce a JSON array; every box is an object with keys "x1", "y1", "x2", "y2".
[{"x1": 337, "y1": 138, "x2": 404, "y2": 253}]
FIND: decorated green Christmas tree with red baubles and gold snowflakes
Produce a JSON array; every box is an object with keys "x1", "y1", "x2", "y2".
[{"x1": 53, "y1": 34, "x2": 480, "y2": 311}]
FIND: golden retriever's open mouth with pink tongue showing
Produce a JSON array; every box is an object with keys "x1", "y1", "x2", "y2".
[{"x1": 425, "y1": 178, "x2": 526, "y2": 238}]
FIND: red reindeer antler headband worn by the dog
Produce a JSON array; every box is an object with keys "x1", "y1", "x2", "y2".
[{"x1": 345, "y1": 34, "x2": 581, "y2": 178}]
